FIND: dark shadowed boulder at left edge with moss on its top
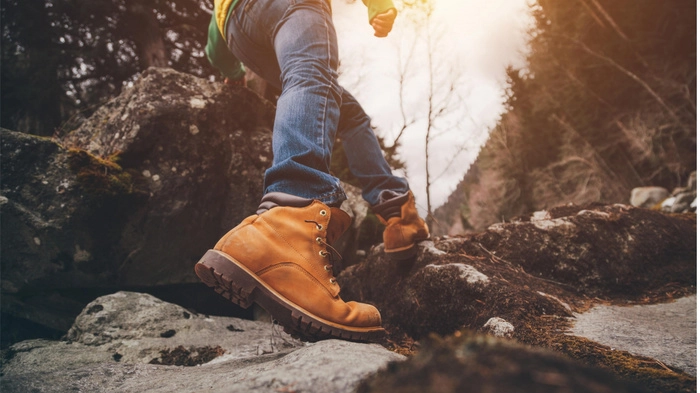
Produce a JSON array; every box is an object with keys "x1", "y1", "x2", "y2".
[{"x1": 0, "y1": 129, "x2": 142, "y2": 336}]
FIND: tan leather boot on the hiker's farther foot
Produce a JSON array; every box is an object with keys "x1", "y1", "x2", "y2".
[{"x1": 372, "y1": 191, "x2": 430, "y2": 260}]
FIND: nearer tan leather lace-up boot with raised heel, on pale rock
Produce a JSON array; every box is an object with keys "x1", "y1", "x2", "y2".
[{"x1": 195, "y1": 193, "x2": 384, "y2": 341}]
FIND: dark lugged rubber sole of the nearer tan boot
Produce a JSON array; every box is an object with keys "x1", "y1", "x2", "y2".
[{"x1": 194, "y1": 250, "x2": 386, "y2": 342}]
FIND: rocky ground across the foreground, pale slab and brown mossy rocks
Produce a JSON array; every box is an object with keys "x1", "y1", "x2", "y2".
[{"x1": 2, "y1": 206, "x2": 697, "y2": 393}]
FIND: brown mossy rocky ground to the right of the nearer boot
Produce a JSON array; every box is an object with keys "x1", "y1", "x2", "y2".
[{"x1": 339, "y1": 205, "x2": 697, "y2": 392}]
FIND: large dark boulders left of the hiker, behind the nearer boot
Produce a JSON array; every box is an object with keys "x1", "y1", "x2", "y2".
[{"x1": 0, "y1": 68, "x2": 367, "y2": 343}]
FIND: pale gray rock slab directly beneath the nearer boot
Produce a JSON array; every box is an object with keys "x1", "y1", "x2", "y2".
[{"x1": 0, "y1": 292, "x2": 403, "y2": 392}]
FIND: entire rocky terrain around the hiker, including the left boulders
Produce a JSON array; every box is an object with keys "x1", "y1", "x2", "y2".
[{"x1": 0, "y1": 69, "x2": 697, "y2": 393}]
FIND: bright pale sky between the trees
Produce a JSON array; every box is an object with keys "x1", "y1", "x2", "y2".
[{"x1": 333, "y1": 0, "x2": 530, "y2": 215}]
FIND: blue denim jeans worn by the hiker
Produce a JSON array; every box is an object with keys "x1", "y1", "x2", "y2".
[{"x1": 226, "y1": 0, "x2": 408, "y2": 205}]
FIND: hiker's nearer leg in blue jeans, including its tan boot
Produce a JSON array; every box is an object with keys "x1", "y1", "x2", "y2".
[{"x1": 195, "y1": 0, "x2": 384, "y2": 340}]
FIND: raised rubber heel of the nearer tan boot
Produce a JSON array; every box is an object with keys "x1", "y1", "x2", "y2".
[{"x1": 194, "y1": 250, "x2": 255, "y2": 308}]
